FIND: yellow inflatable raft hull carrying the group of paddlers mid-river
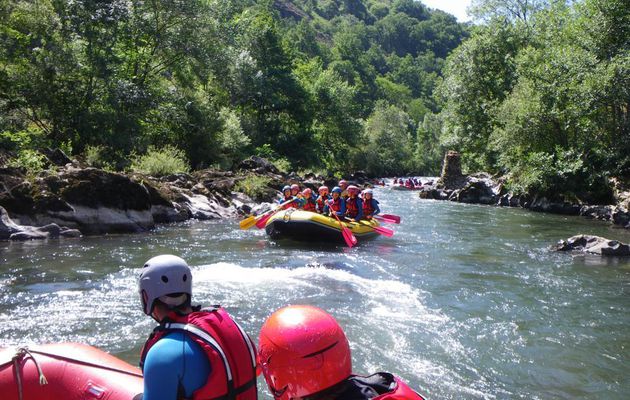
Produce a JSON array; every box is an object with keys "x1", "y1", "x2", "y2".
[{"x1": 265, "y1": 208, "x2": 379, "y2": 243}]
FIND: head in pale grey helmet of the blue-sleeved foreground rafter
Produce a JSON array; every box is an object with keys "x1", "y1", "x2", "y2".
[{"x1": 139, "y1": 254, "x2": 192, "y2": 315}]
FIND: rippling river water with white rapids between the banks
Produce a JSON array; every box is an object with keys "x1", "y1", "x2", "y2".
[{"x1": 0, "y1": 189, "x2": 630, "y2": 399}]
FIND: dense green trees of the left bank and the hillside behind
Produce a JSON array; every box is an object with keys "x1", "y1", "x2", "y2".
[{"x1": 0, "y1": 0, "x2": 467, "y2": 177}]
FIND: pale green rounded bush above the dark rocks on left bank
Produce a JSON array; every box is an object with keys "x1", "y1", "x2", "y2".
[{"x1": 131, "y1": 146, "x2": 190, "y2": 176}]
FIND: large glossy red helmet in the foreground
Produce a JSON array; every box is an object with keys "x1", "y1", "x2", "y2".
[{"x1": 258, "y1": 306, "x2": 352, "y2": 400}]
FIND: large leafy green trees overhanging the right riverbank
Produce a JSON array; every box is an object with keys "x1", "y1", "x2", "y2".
[{"x1": 440, "y1": 0, "x2": 630, "y2": 198}]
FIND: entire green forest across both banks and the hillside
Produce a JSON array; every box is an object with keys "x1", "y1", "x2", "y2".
[{"x1": 0, "y1": 0, "x2": 630, "y2": 202}]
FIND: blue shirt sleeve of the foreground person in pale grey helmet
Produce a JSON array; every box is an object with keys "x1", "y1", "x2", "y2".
[{"x1": 142, "y1": 332, "x2": 212, "y2": 400}]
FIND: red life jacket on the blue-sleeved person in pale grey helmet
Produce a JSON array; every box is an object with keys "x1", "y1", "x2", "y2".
[{"x1": 140, "y1": 306, "x2": 258, "y2": 400}]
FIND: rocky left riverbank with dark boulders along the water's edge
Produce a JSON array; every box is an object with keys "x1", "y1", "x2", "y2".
[{"x1": 0, "y1": 155, "x2": 366, "y2": 240}]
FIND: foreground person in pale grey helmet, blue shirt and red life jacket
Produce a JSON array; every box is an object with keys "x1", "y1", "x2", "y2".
[{"x1": 139, "y1": 255, "x2": 258, "y2": 400}]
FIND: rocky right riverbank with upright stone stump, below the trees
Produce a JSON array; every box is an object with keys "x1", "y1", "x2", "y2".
[{"x1": 419, "y1": 152, "x2": 630, "y2": 229}]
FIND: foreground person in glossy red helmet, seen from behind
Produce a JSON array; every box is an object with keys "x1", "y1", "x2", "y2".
[{"x1": 258, "y1": 305, "x2": 424, "y2": 400}]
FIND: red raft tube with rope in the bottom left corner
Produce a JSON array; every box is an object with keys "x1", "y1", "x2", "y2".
[{"x1": 0, "y1": 343, "x2": 143, "y2": 400}]
